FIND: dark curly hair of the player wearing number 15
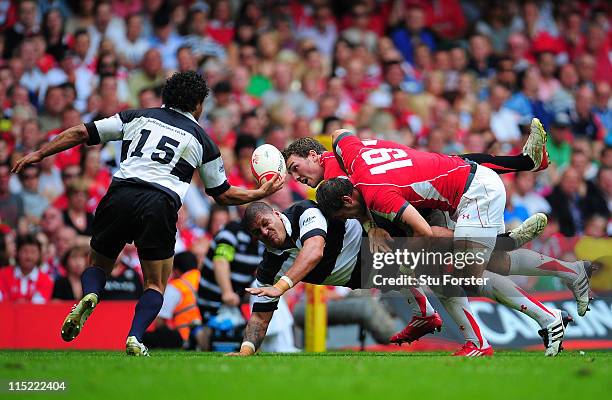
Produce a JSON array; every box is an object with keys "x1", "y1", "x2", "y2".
[{"x1": 162, "y1": 71, "x2": 208, "y2": 112}]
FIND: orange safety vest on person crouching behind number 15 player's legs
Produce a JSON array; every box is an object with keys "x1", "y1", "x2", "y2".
[{"x1": 169, "y1": 269, "x2": 202, "y2": 340}]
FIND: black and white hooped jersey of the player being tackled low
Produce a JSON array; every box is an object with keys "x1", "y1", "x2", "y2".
[{"x1": 253, "y1": 200, "x2": 362, "y2": 312}]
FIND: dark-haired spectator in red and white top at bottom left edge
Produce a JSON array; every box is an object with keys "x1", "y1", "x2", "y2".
[{"x1": 0, "y1": 235, "x2": 53, "y2": 304}]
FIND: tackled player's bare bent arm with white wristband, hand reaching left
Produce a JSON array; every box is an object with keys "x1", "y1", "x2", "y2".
[{"x1": 246, "y1": 236, "x2": 325, "y2": 297}]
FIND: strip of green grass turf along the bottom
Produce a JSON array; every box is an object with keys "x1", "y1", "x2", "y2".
[{"x1": 0, "y1": 351, "x2": 612, "y2": 400}]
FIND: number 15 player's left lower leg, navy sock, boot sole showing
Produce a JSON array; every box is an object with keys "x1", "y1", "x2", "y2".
[{"x1": 61, "y1": 249, "x2": 115, "y2": 342}]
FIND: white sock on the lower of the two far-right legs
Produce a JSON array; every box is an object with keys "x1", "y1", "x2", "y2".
[{"x1": 480, "y1": 271, "x2": 555, "y2": 328}]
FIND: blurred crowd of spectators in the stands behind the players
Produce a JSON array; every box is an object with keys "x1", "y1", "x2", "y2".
[{"x1": 0, "y1": 0, "x2": 612, "y2": 312}]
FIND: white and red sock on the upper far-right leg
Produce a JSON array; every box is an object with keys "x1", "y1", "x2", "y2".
[{"x1": 508, "y1": 249, "x2": 581, "y2": 282}]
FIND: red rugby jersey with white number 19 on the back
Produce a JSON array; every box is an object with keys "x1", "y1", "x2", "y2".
[{"x1": 334, "y1": 133, "x2": 471, "y2": 221}]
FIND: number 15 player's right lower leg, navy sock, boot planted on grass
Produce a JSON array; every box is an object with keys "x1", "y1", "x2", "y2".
[{"x1": 125, "y1": 257, "x2": 174, "y2": 356}]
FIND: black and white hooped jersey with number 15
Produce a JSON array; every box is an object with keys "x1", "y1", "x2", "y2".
[{"x1": 85, "y1": 106, "x2": 230, "y2": 204}]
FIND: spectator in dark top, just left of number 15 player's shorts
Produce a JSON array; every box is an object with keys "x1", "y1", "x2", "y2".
[{"x1": 52, "y1": 246, "x2": 89, "y2": 300}]
